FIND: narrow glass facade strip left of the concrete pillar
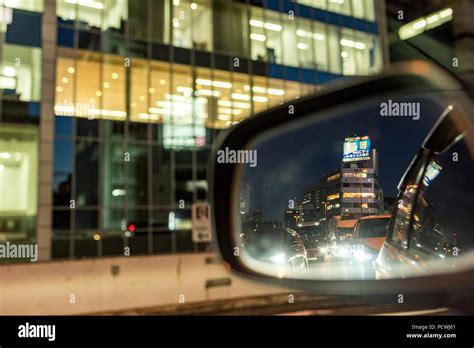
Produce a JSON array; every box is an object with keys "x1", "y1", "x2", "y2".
[{"x1": 0, "y1": 0, "x2": 43, "y2": 243}]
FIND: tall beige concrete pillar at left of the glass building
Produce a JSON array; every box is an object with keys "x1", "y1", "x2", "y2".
[{"x1": 36, "y1": 0, "x2": 57, "y2": 260}]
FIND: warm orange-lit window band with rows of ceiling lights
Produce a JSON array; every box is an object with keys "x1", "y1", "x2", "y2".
[{"x1": 55, "y1": 48, "x2": 313, "y2": 129}]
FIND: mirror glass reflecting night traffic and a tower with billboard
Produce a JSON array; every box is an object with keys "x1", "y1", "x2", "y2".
[{"x1": 235, "y1": 93, "x2": 474, "y2": 280}]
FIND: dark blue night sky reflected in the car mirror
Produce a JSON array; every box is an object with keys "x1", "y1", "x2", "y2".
[{"x1": 242, "y1": 97, "x2": 445, "y2": 221}]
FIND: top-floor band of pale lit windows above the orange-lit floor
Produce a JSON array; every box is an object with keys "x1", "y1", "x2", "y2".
[{"x1": 57, "y1": 0, "x2": 381, "y2": 75}]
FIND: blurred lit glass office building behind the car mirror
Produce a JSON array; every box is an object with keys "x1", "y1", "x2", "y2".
[{"x1": 0, "y1": 0, "x2": 387, "y2": 260}]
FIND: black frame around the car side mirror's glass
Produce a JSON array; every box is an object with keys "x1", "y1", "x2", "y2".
[{"x1": 208, "y1": 61, "x2": 474, "y2": 295}]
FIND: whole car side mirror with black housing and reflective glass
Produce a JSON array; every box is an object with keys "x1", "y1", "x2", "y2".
[{"x1": 210, "y1": 61, "x2": 474, "y2": 294}]
